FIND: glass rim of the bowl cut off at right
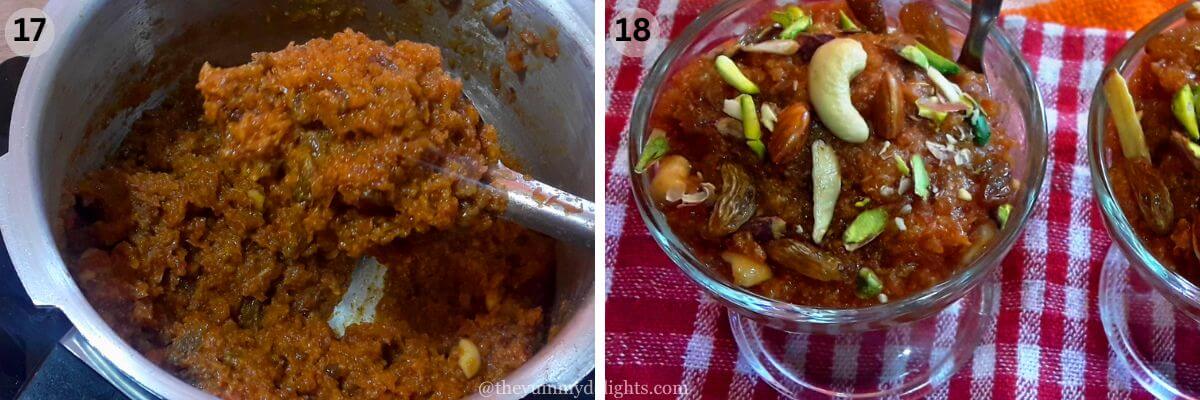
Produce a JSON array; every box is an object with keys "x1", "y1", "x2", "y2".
[{"x1": 1087, "y1": 1, "x2": 1200, "y2": 308}]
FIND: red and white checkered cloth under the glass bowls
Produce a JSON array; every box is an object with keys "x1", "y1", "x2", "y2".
[{"x1": 605, "y1": 0, "x2": 1171, "y2": 399}]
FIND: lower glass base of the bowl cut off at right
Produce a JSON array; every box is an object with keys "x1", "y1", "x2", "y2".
[{"x1": 1099, "y1": 245, "x2": 1200, "y2": 399}]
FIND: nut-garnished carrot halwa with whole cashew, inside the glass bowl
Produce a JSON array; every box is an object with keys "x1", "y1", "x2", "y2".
[{"x1": 635, "y1": 0, "x2": 1020, "y2": 309}]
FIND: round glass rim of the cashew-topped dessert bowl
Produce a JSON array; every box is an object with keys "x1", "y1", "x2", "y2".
[{"x1": 618, "y1": 0, "x2": 1049, "y2": 329}]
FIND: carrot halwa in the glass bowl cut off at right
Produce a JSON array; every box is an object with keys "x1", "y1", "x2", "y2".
[{"x1": 1105, "y1": 10, "x2": 1200, "y2": 283}]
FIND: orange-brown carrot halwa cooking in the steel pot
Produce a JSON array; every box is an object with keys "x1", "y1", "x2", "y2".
[{"x1": 62, "y1": 30, "x2": 554, "y2": 399}]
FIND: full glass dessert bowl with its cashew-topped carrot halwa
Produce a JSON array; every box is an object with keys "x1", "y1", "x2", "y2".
[{"x1": 629, "y1": 1, "x2": 1046, "y2": 396}]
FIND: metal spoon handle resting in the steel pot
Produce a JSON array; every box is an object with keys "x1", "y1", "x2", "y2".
[{"x1": 488, "y1": 165, "x2": 596, "y2": 249}]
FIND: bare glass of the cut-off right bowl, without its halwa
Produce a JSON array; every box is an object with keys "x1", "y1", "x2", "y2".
[{"x1": 1087, "y1": 2, "x2": 1200, "y2": 399}]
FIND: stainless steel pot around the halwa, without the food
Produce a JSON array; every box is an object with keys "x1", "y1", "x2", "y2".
[{"x1": 0, "y1": 0, "x2": 595, "y2": 399}]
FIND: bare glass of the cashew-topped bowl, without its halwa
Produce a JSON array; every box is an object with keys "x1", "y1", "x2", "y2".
[{"x1": 626, "y1": 0, "x2": 1048, "y2": 398}]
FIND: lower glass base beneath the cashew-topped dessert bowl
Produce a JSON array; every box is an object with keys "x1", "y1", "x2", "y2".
[{"x1": 728, "y1": 274, "x2": 1000, "y2": 399}]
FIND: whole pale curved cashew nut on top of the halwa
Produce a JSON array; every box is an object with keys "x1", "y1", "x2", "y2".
[{"x1": 809, "y1": 37, "x2": 870, "y2": 143}]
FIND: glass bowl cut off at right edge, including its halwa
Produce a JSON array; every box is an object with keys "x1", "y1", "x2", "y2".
[{"x1": 1087, "y1": 2, "x2": 1200, "y2": 398}]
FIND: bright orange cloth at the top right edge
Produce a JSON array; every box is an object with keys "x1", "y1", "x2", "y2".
[{"x1": 1004, "y1": 0, "x2": 1180, "y2": 30}]
